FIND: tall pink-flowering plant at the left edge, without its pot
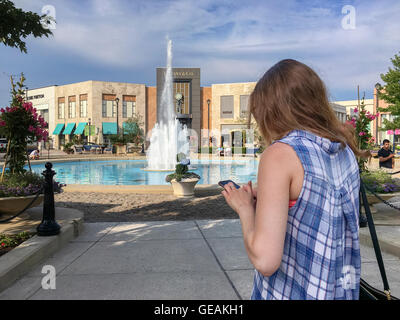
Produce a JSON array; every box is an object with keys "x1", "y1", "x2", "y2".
[{"x1": 0, "y1": 74, "x2": 49, "y2": 175}]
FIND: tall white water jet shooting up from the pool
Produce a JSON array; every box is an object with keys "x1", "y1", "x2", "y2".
[{"x1": 146, "y1": 39, "x2": 189, "y2": 171}]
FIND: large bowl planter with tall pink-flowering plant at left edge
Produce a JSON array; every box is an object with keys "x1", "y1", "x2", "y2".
[{"x1": 0, "y1": 74, "x2": 62, "y2": 213}]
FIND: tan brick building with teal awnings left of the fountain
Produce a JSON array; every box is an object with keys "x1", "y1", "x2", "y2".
[{"x1": 50, "y1": 81, "x2": 146, "y2": 149}]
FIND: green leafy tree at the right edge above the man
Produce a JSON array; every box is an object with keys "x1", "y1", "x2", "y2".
[{"x1": 378, "y1": 55, "x2": 400, "y2": 131}]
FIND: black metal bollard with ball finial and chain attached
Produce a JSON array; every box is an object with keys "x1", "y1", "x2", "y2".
[{"x1": 36, "y1": 162, "x2": 61, "y2": 237}]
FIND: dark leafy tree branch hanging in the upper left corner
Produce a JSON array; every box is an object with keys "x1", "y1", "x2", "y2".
[{"x1": 0, "y1": 0, "x2": 54, "y2": 53}]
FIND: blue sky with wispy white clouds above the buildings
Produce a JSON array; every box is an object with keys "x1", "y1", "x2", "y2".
[{"x1": 0, "y1": 0, "x2": 400, "y2": 106}]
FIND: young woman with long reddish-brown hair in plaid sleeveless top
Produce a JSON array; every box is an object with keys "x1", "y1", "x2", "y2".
[{"x1": 222, "y1": 60, "x2": 369, "y2": 300}]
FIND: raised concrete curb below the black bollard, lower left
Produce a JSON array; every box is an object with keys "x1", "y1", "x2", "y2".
[{"x1": 0, "y1": 218, "x2": 83, "y2": 292}]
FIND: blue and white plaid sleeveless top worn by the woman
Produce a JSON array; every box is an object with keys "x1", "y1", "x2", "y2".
[{"x1": 251, "y1": 130, "x2": 361, "y2": 300}]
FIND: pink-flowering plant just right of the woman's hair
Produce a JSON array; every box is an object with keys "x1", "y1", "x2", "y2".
[{"x1": 346, "y1": 98, "x2": 379, "y2": 171}]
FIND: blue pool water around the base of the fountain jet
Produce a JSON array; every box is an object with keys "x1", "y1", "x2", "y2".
[{"x1": 28, "y1": 160, "x2": 258, "y2": 185}]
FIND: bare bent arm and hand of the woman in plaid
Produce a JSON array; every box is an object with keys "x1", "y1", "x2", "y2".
[{"x1": 223, "y1": 143, "x2": 297, "y2": 276}]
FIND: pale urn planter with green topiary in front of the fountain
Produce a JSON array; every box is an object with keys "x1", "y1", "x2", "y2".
[{"x1": 165, "y1": 155, "x2": 200, "y2": 198}]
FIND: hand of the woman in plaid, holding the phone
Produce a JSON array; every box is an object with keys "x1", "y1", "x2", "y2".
[{"x1": 222, "y1": 181, "x2": 257, "y2": 216}]
